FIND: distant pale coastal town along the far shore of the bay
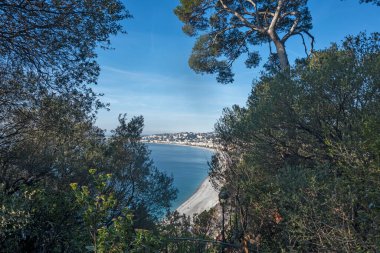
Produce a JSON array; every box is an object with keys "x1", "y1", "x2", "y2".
[{"x1": 142, "y1": 132, "x2": 216, "y2": 148}]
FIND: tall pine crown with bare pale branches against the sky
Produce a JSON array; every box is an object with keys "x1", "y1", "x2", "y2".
[{"x1": 175, "y1": 0, "x2": 314, "y2": 83}]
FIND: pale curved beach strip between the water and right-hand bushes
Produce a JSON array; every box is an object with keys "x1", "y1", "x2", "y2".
[{"x1": 177, "y1": 177, "x2": 218, "y2": 217}]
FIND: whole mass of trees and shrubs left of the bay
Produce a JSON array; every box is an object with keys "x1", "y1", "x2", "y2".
[{"x1": 0, "y1": 0, "x2": 176, "y2": 252}]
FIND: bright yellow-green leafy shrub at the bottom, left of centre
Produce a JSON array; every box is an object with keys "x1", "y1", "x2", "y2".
[{"x1": 70, "y1": 169, "x2": 157, "y2": 252}]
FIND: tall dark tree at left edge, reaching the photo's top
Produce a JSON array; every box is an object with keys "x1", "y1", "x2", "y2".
[{"x1": 0, "y1": 0, "x2": 130, "y2": 205}]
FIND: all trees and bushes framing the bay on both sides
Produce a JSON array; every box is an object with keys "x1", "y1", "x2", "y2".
[{"x1": 0, "y1": 0, "x2": 380, "y2": 252}]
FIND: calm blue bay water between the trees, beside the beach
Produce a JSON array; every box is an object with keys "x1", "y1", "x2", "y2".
[{"x1": 148, "y1": 144, "x2": 212, "y2": 210}]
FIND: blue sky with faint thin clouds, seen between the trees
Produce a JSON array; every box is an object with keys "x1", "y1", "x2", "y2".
[{"x1": 94, "y1": 0, "x2": 380, "y2": 134}]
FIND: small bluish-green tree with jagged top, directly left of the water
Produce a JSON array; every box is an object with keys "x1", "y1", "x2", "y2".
[{"x1": 105, "y1": 115, "x2": 177, "y2": 221}]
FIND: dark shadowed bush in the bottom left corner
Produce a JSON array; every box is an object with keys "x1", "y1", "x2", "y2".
[{"x1": 0, "y1": 183, "x2": 85, "y2": 252}]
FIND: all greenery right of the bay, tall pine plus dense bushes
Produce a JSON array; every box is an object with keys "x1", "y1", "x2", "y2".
[{"x1": 175, "y1": 0, "x2": 380, "y2": 252}]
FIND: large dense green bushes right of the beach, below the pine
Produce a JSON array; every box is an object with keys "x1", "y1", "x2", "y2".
[{"x1": 211, "y1": 34, "x2": 380, "y2": 252}]
